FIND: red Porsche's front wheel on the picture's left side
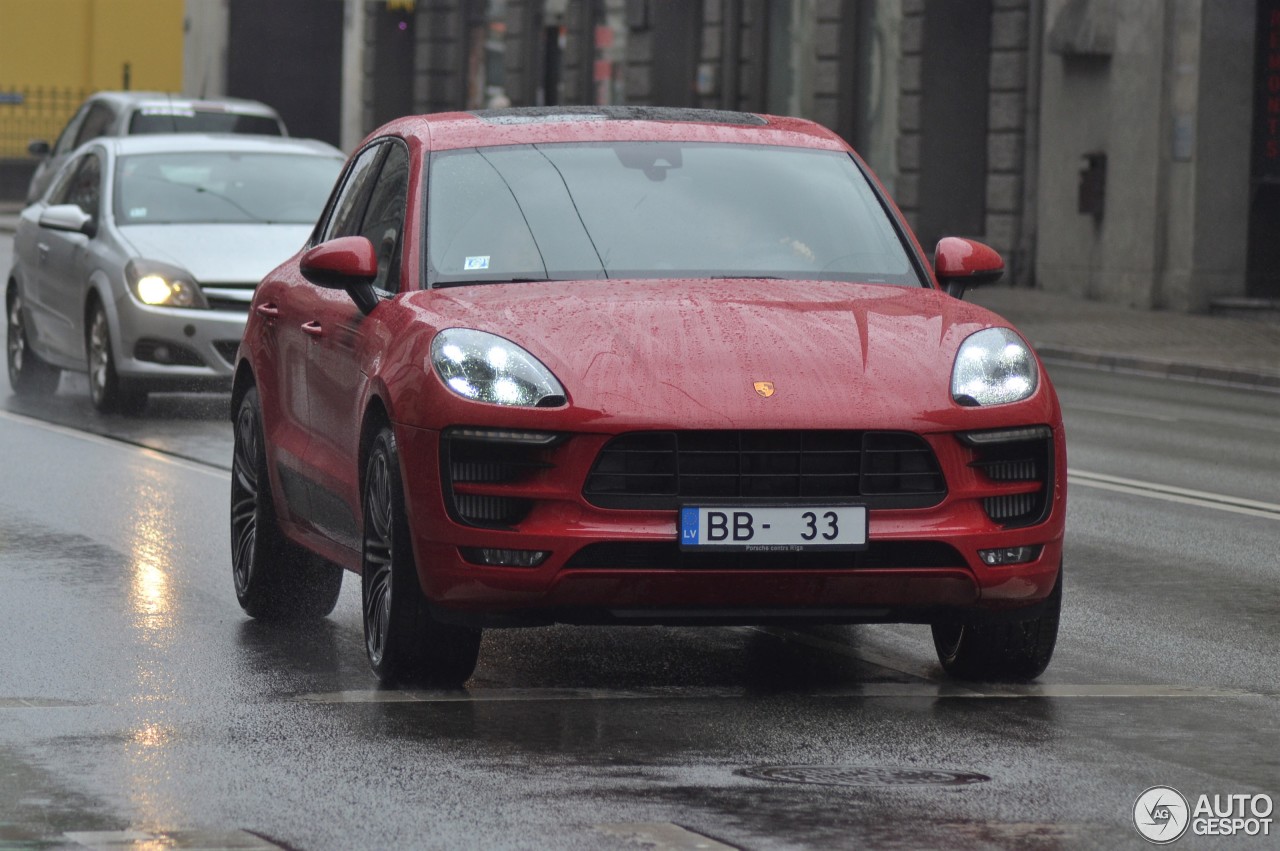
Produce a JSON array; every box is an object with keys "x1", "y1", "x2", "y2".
[{"x1": 361, "y1": 426, "x2": 480, "y2": 686}]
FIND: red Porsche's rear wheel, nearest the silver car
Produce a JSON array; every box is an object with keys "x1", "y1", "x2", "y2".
[{"x1": 230, "y1": 388, "x2": 342, "y2": 621}]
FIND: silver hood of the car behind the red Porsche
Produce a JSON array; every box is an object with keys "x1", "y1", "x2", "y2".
[{"x1": 118, "y1": 224, "x2": 312, "y2": 284}]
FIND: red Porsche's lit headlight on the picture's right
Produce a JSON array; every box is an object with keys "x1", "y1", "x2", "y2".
[{"x1": 951, "y1": 328, "x2": 1039, "y2": 406}]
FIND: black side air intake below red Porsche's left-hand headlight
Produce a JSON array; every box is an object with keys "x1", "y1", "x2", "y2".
[{"x1": 440, "y1": 430, "x2": 559, "y2": 529}]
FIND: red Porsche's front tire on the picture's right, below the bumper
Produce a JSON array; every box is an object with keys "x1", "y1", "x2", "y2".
[{"x1": 933, "y1": 567, "x2": 1062, "y2": 682}]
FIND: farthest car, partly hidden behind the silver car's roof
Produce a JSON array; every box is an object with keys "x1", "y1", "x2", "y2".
[{"x1": 27, "y1": 91, "x2": 288, "y2": 203}]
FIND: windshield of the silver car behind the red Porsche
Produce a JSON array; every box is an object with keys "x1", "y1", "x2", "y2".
[{"x1": 115, "y1": 151, "x2": 342, "y2": 225}]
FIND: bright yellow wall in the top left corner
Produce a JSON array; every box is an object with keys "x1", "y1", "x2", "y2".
[{"x1": 0, "y1": 0, "x2": 183, "y2": 91}]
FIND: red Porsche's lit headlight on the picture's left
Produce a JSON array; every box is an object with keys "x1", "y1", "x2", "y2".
[{"x1": 431, "y1": 328, "x2": 564, "y2": 408}]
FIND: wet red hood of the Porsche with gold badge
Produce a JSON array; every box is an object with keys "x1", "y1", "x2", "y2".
[{"x1": 410, "y1": 280, "x2": 1039, "y2": 431}]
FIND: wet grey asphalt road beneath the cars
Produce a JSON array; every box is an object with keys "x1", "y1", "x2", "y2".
[{"x1": 0, "y1": 236, "x2": 1280, "y2": 850}]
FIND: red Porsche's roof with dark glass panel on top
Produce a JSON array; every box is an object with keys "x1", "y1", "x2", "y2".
[{"x1": 371, "y1": 106, "x2": 849, "y2": 151}]
